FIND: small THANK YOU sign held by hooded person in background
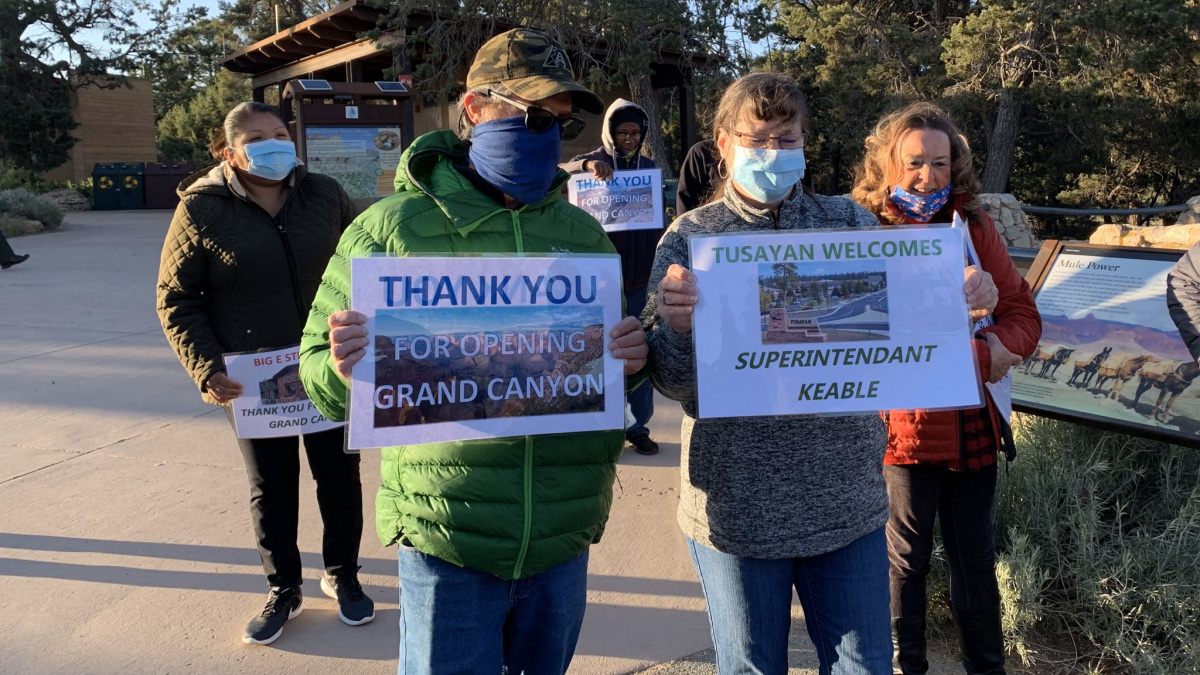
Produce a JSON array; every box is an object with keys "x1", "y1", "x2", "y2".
[{"x1": 566, "y1": 169, "x2": 662, "y2": 232}]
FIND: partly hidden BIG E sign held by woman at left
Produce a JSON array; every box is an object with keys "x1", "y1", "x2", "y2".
[{"x1": 224, "y1": 347, "x2": 344, "y2": 438}]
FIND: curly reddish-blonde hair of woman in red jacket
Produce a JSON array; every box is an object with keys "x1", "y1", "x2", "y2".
[{"x1": 851, "y1": 102, "x2": 983, "y2": 223}]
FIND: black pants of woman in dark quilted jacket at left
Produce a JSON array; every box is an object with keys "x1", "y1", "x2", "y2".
[{"x1": 227, "y1": 420, "x2": 362, "y2": 586}]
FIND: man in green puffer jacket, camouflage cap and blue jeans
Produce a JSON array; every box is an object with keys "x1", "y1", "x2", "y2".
[{"x1": 300, "y1": 29, "x2": 647, "y2": 674}]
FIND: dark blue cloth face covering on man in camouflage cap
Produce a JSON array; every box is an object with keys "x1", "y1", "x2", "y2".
[{"x1": 470, "y1": 117, "x2": 563, "y2": 204}]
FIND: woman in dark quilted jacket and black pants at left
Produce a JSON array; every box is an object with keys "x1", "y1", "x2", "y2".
[{"x1": 157, "y1": 102, "x2": 374, "y2": 645}]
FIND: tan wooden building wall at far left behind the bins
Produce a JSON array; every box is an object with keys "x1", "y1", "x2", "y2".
[{"x1": 46, "y1": 77, "x2": 157, "y2": 181}]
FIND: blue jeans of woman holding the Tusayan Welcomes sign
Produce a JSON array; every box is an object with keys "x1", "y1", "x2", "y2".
[{"x1": 688, "y1": 527, "x2": 892, "y2": 675}]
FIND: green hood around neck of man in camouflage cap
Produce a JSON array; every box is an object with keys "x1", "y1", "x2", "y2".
[{"x1": 396, "y1": 130, "x2": 571, "y2": 237}]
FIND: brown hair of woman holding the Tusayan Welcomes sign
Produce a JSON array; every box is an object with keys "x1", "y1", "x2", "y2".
[{"x1": 712, "y1": 72, "x2": 809, "y2": 202}]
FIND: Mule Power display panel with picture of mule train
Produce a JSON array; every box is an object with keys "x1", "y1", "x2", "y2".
[{"x1": 1013, "y1": 241, "x2": 1200, "y2": 447}]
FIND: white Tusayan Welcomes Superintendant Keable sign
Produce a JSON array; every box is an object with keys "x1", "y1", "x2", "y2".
[{"x1": 690, "y1": 228, "x2": 983, "y2": 418}]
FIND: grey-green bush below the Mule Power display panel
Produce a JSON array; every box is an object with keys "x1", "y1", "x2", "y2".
[{"x1": 996, "y1": 416, "x2": 1200, "y2": 674}]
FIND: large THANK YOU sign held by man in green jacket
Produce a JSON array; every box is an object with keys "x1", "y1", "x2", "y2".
[{"x1": 349, "y1": 255, "x2": 625, "y2": 448}]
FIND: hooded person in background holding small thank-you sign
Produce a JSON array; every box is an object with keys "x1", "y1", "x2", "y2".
[{"x1": 560, "y1": 98, "x2": 662, "y2": 455}]
